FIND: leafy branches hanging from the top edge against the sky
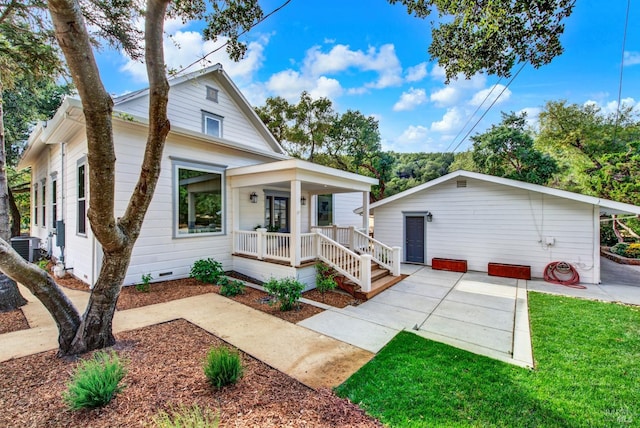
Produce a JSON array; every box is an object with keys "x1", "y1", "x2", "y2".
[{"x1": 389, "y1": 0, "x2": 575, "y2": 80}]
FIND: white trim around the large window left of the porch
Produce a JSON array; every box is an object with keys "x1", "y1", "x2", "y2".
[{"x1": 170, "y1": 157, "x2": 227, "y2": 239}]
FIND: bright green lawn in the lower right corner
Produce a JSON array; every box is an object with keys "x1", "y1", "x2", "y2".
[{"x1": 336, "y1": 293, "x2": 640, "y2": 427}]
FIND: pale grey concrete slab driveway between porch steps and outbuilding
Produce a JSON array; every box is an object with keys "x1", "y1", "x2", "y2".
[{"x1": 299, "y1": 265, "x2": 533, "y2": 366}]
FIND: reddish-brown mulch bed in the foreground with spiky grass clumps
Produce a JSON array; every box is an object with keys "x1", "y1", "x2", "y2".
[{"x1": 0, "y1": 320, "x2": 382, "y2": 427}]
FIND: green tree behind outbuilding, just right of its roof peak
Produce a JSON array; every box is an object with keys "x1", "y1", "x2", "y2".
[{"x1": 471, "y1": 113, "x2": 558, "y2": 185}]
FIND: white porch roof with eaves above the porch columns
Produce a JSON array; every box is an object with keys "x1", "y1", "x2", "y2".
[{"x1": 227, "y1": 159, "x2": 378, "y2": 194}]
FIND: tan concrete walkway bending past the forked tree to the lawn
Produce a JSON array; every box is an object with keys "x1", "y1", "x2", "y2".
[{"x1": 0, "y1": 287, "x2": 374, "y2": 388}]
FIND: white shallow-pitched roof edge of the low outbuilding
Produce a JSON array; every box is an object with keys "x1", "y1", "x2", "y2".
[{"x1": 369, "y1": 169, "x2": 640, "y2": 215}]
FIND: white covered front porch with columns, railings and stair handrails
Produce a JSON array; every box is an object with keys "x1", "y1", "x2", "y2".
[{"x1": 227, "y1": 159, "x2": 400, "y2": 291}]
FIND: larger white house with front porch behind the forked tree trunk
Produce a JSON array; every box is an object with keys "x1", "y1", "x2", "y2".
[{"x1": 19, "y1": 65, "x2": 400, "y2": 287}]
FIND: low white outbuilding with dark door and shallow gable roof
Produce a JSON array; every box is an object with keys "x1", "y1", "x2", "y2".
[{"x1": 370, "y1": 171, "x2": 640, "y2": 284}]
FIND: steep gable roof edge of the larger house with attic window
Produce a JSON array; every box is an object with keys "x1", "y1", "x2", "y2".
[{"x1": 113, "y1": 64, "x2": 286, "y2": 155}]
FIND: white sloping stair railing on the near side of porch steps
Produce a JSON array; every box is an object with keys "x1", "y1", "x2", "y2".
[{"x1": 316, "y1": 231, "x2": 371, "y2": 292}]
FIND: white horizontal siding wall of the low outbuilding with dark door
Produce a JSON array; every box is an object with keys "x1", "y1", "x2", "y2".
[{"x1": 375, "y1": 179, "x2": 599, "y2": 283}]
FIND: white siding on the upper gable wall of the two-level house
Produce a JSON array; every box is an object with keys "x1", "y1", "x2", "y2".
[{"x1": 116, "y1": 73, "x2": 273, "y2": 151}]
